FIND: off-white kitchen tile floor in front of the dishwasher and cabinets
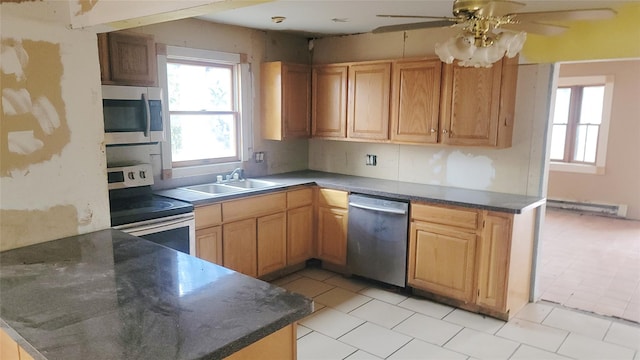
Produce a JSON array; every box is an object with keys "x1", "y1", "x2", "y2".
[{"x1": 274, "y1": 268, "x2": 640, "y2": 360}]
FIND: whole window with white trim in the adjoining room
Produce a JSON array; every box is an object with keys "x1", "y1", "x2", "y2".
[{"x1": 550, "y1": 76, "x2": 613, "y2": 173}]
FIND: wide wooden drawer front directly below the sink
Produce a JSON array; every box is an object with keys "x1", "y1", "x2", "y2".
[{"x1": 222, "y1": 192, "x2": 287, "y2": 223}]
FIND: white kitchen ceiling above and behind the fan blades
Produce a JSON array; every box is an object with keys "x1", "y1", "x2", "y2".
[{"x1": 199, "y1": 0, "x2": 637, "y2": 37}]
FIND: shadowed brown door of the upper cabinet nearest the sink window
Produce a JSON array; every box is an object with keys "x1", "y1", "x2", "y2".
[{"x1": 282, "y1": 63, "x2": 311, "y2": 139}]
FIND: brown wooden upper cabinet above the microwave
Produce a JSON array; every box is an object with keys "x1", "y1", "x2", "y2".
[{"x1": 98, "y1": 31, "x2": 158, "y2": 86}]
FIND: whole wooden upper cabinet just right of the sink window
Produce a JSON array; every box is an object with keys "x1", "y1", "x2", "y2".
[{"x1": 260, "y1": 61, "x2": 311, "y2": 140}]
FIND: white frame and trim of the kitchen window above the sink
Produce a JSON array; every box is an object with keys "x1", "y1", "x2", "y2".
[{"x1": 157, "y1": 45, "x2": 253, "y2": 179}]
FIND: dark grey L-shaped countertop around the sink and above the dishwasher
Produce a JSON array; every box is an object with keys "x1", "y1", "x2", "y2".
[{"x1": 157, "y1": 170, "x2": 546, "y2": 214}]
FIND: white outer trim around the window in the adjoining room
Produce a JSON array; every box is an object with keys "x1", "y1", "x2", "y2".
[{"x1": 549, "y1": 75, "x2": 614, "y2": 175}]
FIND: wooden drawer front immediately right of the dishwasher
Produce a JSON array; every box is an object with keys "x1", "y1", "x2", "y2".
[{"x1": 411, "y1": 203, "x2": 479, "y2": 230}]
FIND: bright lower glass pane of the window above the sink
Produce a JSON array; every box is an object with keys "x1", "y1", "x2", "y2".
[{"x1": 171, "y1": 114, "x2": 238, "y2": 162}]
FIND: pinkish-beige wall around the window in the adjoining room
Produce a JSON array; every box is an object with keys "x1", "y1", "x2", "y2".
[{"x1": 548, "y1": 59, "x2": 640, "y2": 220}]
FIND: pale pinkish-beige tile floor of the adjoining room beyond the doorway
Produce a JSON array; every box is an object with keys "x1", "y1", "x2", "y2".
[{"x1": 538, "y1": 209, "x2": 640, "y2": 322}]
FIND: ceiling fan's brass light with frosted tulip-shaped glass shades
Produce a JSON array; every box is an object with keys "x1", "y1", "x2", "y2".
[{"x1": 435, "y1": 17, "x2": 527, "y2": 67}]
